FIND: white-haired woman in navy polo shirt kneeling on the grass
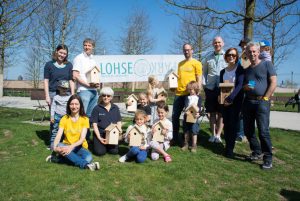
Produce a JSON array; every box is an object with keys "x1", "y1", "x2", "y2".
[{"x1": 91, "y1": 87, "x2": 121, "y2": 156}]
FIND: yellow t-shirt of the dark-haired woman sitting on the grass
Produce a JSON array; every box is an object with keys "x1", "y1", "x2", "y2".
[{"x1": 59, "y1": 115, "x2": 90, "y2": 149}]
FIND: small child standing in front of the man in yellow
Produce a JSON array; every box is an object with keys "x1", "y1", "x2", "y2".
[{"x1": 181, "y1": 81, "x2": 202, "y2": 153}]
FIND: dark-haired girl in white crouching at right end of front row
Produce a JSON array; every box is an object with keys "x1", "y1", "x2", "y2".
[{"x1": 150, "y1": 101, "x2": 173, "y2": 163}]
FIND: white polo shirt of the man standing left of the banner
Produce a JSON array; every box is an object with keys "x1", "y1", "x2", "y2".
[{"x1": 73, "y1": 52, "x2": 97, "y2": 92}]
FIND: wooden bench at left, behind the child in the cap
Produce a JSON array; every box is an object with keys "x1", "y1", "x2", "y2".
[{"x1": 30, "y1": 89, "x2": 48, "y2": 122}]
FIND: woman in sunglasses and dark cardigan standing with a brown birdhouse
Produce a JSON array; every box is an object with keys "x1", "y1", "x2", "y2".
[{"x1": 220, "y1": 48, "x2": 244, "y2": 158}]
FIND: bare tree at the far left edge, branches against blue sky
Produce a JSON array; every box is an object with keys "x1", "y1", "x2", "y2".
[{"x1": 0, "y1": 0, "x2": 44, "y2": 97}]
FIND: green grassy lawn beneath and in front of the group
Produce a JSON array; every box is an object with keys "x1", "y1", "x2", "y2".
[{"x1": 0, "y1": 107, "x2": 300, "y2": 201}]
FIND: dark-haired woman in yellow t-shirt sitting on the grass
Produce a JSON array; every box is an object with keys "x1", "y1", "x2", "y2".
[{"x1": 46, "y1": 95, "x2": 100, "y2": 171}]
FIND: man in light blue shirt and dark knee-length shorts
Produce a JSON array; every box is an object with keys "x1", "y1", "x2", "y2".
[{"x1": 202, "y1": 36, "x2": 227, "y2": 143}]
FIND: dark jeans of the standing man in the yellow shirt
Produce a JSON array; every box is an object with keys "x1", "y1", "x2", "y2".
[{"x1": 172, "y1": 96, "x2": 186, "y2": 145}]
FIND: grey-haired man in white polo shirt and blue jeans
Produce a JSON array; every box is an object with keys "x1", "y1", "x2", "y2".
[{"x1": 73, "y1": 38, "x2": 100, "y2": 117}]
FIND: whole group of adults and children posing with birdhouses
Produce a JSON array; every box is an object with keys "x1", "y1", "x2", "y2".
[{"x1": 44, "y1": 36, "x2": 276, "y2": 170}]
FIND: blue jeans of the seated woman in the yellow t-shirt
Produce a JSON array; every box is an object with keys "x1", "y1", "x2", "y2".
[{"x1": 58, "y1": 143, "x2": 93, "y2": 169}]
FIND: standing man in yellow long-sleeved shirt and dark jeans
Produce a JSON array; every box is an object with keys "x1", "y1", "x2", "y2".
[{"x1": 172, "y1": 44, "x2": 202, "y2": 144}]
